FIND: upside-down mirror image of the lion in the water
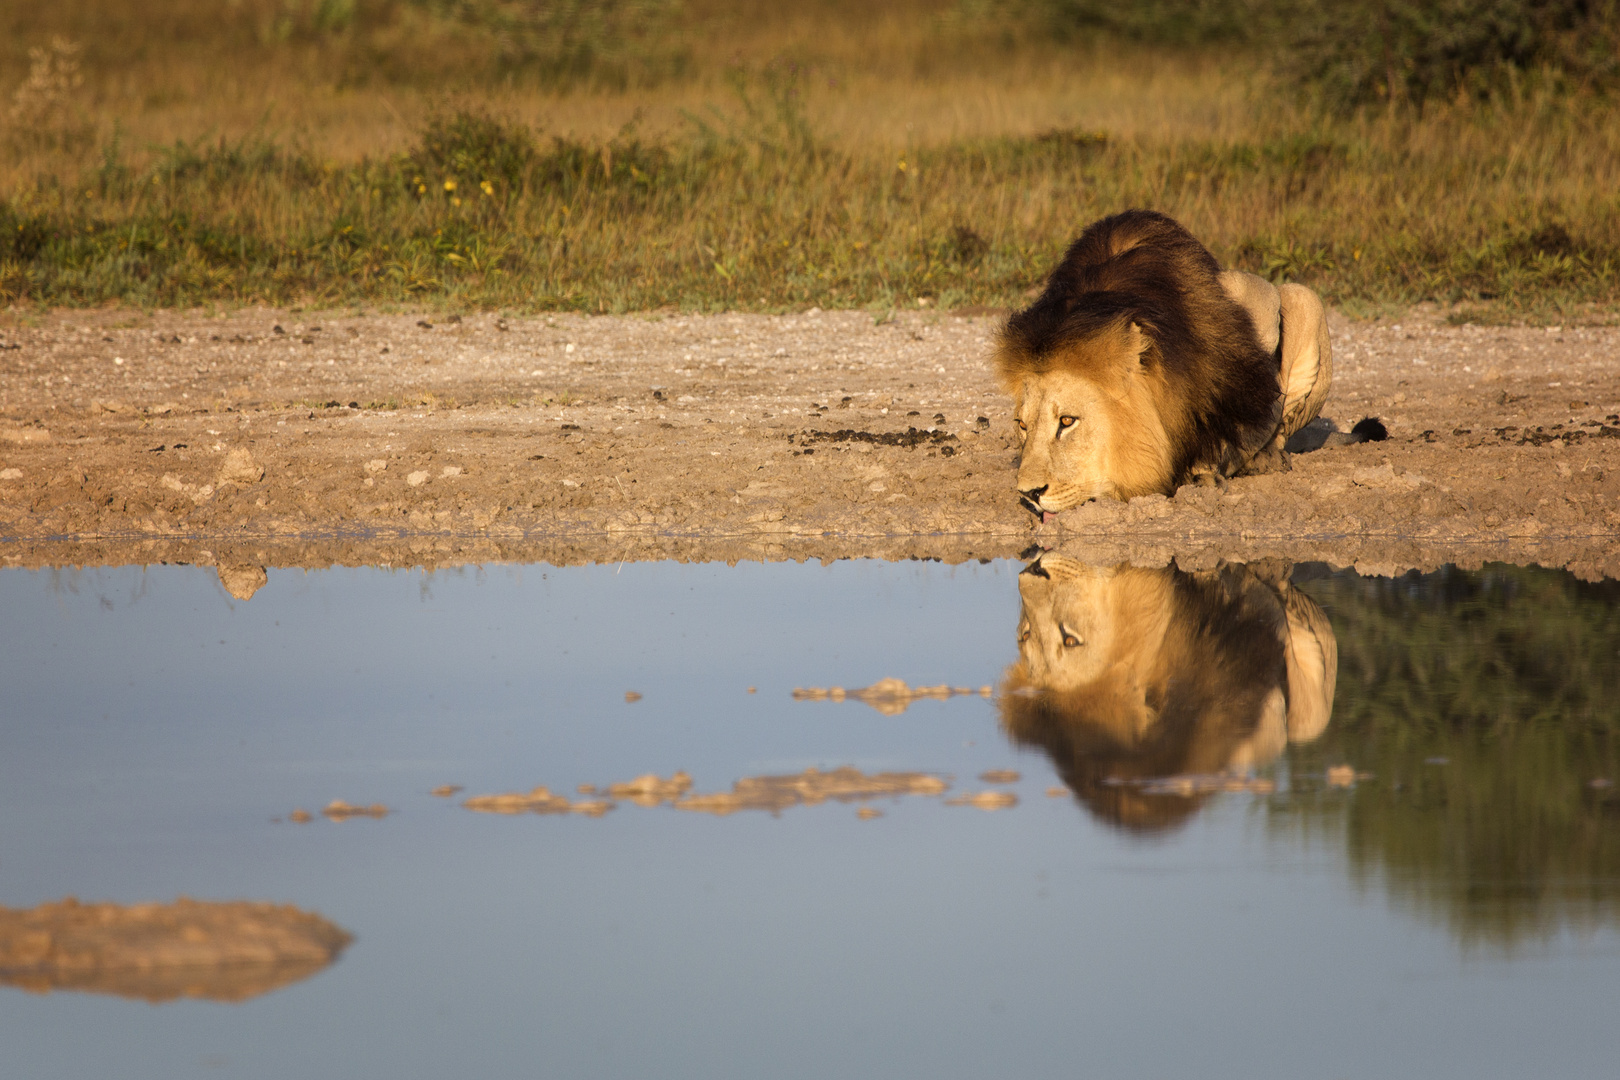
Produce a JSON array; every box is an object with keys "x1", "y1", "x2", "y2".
[{"x1": 1000, "y1": 554, "x2": 1338, "y2": 832}]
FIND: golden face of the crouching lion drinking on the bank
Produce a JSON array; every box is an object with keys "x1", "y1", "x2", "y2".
[{"x1": 1013, "y1": 325, "x2": 1171, "y2": 517}]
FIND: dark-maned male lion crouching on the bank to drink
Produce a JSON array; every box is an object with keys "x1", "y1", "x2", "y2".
[{"x1": 996, "y1": 210, "x2": 1382, "y2": 521}]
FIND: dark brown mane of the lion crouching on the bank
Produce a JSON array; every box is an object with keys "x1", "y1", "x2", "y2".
[{"x1": 1000, "y1": 210, "x2": 1280, "y2": 484}]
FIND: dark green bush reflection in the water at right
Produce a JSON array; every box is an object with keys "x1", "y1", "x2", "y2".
[{"x1": 1273, "y1": 567, "x2": 1620, "y2": 946}]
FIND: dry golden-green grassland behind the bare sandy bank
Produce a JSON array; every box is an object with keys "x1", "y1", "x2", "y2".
[{"x1": 0, "y1": 0, "x2": 1620, "y2": 319}]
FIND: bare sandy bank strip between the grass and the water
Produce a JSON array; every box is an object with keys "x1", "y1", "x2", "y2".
[{"x1": 0, "y1": 309, "x2": 1620, "y2": 576}]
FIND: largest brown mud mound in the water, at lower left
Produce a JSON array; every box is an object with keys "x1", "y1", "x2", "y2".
[{"x1": 0, "y1": 897, "x2": 353, "y2": 1002}]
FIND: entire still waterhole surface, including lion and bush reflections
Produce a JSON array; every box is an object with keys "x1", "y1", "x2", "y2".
[{"x1": 0, "y1": 557, "x2": 1620, "y2": 1078}]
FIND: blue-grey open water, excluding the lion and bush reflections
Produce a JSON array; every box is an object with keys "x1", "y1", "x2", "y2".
[{"x1": 0, "y1": 562, "x2": 1620, "y2": 1080}]
